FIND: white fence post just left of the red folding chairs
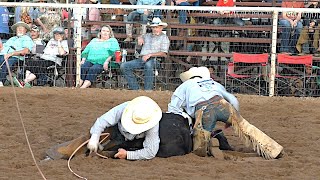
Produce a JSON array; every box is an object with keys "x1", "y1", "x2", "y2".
[{"x1": 269, "y1": 11, "x2": 279, "y2": 96}]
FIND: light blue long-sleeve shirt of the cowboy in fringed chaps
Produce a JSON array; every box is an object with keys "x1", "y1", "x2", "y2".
[{"x1": 168, "y1": 78, "x2": 239, "y2": 118}]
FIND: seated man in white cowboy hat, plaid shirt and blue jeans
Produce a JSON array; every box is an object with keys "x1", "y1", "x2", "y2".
[{"x1": 120, "y1": 17, "x2": 170, "y2": 90}]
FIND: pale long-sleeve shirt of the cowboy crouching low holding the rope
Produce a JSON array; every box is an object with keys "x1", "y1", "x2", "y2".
[{"x1": 90, "y1": 102, "x2": 160, "y2": 160}]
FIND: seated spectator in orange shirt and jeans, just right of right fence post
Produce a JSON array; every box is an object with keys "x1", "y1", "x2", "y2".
[{"x1": 279, "y1": 0, "x2": 304, "y2": 54}]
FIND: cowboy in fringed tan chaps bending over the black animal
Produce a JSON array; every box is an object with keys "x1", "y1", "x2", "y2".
[{"x1": 168, "y1": 67, "x2": 283, "y2": 159}]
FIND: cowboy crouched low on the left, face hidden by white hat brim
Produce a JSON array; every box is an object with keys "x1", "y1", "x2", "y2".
[{"x1": 87, "y1": 96, "x2": 162, "y2": 160}]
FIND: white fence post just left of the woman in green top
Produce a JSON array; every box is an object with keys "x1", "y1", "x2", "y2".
[{"x1": 74, "y1": 7, "x2": 82, "y2": 87}]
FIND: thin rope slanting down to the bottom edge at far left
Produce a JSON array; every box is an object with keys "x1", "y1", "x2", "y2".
[{"x1": 5, "y1": 60, "x2": 46, "y2": 180}]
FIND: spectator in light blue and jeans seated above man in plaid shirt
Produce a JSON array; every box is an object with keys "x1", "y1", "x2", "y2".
[{"x1": 124, "y1": 0, "x2": 166, "y2": 42}]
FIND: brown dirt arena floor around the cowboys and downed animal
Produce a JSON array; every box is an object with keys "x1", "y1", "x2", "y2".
[{"x1": 0, "y1": 87, "x2": 320, "y2": 180}]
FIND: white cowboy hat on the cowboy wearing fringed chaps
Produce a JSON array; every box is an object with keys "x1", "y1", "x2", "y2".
[{"x1": 180, "y1": 66, "x2": 210, "y2": 82}]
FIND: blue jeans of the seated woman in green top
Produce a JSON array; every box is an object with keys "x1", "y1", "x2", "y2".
[{"x1": 81, "y1": 61, "x2": 103, "y2": 82}]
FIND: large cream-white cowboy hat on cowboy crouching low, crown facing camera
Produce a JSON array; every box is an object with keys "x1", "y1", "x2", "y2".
[{"x1": 121, "y1": 96, "x2": 162, "y2": 134}]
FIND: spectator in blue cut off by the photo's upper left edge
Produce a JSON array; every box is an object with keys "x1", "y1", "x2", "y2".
[{"x1": 0, "y1": 6, "x2": 10, "y2": 42}]
